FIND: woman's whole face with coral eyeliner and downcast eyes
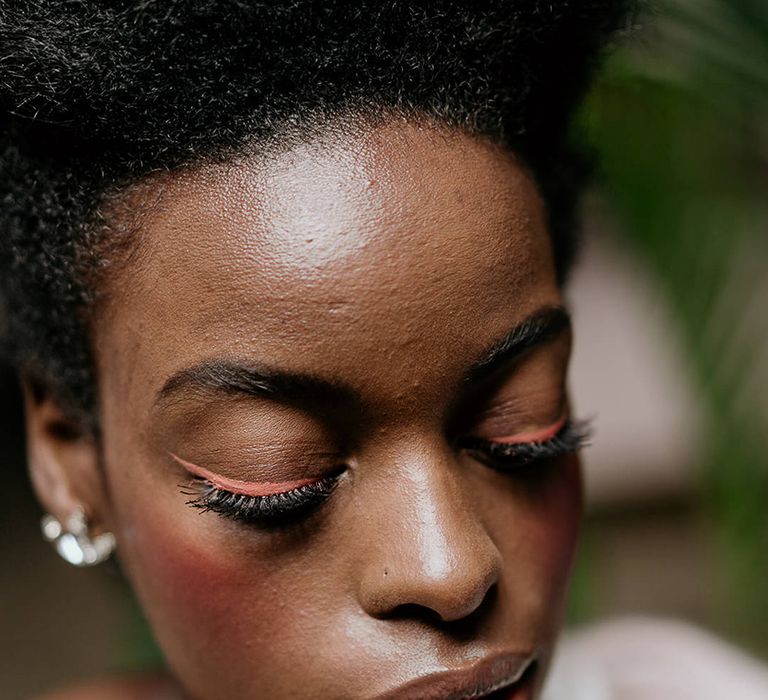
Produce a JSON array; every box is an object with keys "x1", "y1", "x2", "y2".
[{"x1": 94, "y1": 122, "x2": 580, "y2": 700}]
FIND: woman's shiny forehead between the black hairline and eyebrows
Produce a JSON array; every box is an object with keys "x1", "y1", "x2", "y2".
[{"x1": 96, "y1": 123, "x2": 558, "y2": 410}]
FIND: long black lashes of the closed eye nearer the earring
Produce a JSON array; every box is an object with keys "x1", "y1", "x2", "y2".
[{"x1": 182, "y1": 471, "x2": 341, "y2": 527}]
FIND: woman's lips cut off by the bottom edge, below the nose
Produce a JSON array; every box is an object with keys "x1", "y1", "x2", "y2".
[{"x1": 377, "y1": 653, "x2": 536, "y2": 700}]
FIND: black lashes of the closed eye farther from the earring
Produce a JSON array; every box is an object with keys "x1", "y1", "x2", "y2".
[{"x1": 459, "y1": 421, "x2": 591, "y2": 473}]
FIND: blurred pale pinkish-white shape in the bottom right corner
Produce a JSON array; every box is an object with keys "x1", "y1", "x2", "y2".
[{"x1": 553, "y1": 618, "x2": 768, "y2": 700}]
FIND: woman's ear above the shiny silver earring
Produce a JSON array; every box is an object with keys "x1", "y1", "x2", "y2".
[{"x1": 22, "y1": 378, "x2": 108, "y2": 532}]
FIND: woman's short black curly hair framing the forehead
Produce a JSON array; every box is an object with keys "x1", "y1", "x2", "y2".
[{"x1": 0, "y1": 0, "x2": 628, "y2": 426}]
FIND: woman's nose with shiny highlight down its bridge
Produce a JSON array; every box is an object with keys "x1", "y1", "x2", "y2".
[{"x1": 359, "y1": 442, "x2": 502, "y2": 622}]
